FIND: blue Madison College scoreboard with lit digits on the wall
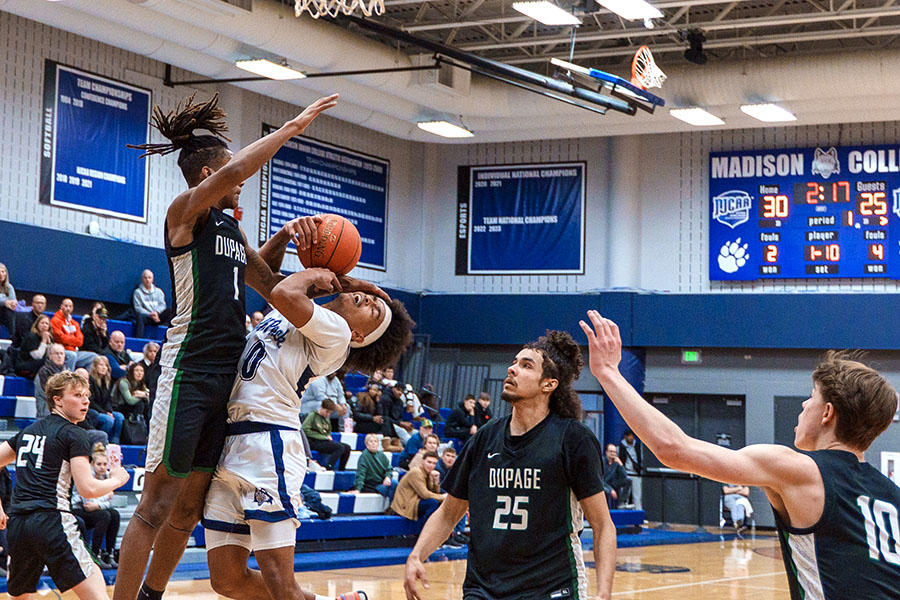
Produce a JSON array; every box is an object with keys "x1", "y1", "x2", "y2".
[{"x1": 709, "y1": 146, "x2": 900, "y2": 281}]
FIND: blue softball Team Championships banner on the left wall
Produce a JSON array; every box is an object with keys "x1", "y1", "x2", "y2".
[{"x1": 40, "y1": 60, "x2": 151, "y2": 223}]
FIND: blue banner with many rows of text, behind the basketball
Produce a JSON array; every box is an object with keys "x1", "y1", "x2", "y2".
[{"x1": 259, "y1": 130, "x2": 391, "y2": 271}]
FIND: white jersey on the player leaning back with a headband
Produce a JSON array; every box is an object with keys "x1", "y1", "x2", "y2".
[{"x1": 228, "y1": 305, "x2": 350, "y2": 429}]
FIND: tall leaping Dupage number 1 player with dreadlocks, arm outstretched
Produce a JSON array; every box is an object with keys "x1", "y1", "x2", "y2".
[{"x1": 115, "y1": 90, "x2": 384, "y2": 600}]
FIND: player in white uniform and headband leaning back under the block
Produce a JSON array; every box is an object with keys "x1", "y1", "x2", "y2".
[{"x1": 203, "y1": 269, "x2": 414, "y2": 600}]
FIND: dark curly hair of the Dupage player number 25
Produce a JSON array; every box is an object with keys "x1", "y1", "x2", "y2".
[{"x1": 525, "y1": 330, "x2": 584, "y2": 419}]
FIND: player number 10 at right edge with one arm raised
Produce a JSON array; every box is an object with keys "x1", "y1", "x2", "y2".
[{"x1": 580, "y1": 310, "x2": 900, "y2": 600}]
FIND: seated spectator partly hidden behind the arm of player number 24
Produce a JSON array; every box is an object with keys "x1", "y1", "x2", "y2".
[{"x1": 72, "y1": 444, "x2": 121, "y2": 569}]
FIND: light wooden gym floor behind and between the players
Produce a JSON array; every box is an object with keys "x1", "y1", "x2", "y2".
[{"x1": 24, "y1": 536, "x2": 790, "y2": 600}]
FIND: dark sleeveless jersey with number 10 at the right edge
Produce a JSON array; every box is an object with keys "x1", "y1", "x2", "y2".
[{"x1": 775, "y1": 450, "x2": 900, "y2": 600}]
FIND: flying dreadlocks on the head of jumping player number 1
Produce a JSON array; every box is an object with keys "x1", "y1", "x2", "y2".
[{"x1": 127, "y1": 92, "x2": 231, "y2": 185}]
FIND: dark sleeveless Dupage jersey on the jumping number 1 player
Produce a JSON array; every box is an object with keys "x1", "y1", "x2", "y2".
[{"x1": 160, "y1": 208, "x2": 247, "y2": 373}]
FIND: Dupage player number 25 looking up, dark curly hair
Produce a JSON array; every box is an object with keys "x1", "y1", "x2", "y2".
[{"x1": 404, "y1": 331, "x2": 616, "y2": 600}]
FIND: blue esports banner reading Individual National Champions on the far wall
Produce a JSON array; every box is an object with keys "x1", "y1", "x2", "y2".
[{"x1": 456, "y1": 162, "x2": 585, "y2": 275}]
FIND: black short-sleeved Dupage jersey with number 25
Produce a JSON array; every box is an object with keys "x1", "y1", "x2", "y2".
[{"x1": 443, "y1": 414, "x2": 603, "y2": 600}]
